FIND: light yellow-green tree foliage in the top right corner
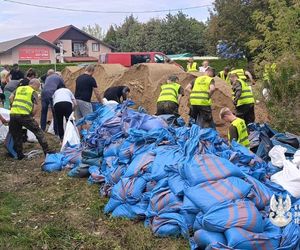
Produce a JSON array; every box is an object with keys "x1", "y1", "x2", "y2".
[{"x1": 247, "y1": 0, "x2": 300, "y2": 63}]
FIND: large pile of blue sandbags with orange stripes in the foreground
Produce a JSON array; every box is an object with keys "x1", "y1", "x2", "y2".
[{"x1": 45, "y1": 103, "x2": 300, "y2": 250}]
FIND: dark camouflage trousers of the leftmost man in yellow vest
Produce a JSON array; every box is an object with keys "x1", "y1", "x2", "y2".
[{"x1": 9, "y1": 115, "x2": 49, "y2": 157}]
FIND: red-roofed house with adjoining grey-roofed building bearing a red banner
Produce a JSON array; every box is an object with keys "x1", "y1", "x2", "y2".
[{"x1": 0, "y1": 25, "x2": 113, "y2": 65}]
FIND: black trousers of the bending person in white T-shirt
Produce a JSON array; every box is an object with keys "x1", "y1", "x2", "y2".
[{"x1": 54, "y1": 102, "x2": 73, "y2": 140}]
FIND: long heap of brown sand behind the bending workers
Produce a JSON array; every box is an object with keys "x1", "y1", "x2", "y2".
[{"x1": 63, "y1": 63, "x2": 267, "y2": 135}]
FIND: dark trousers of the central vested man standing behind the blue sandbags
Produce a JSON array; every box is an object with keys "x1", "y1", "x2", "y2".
[{"x1": 190, "y1": 105, "x2": 216, "y2": 128}]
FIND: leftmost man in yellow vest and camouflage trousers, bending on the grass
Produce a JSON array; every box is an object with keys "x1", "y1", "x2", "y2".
[{"x1": 9, "y1": 78, "x2": 50, "y2": 160}]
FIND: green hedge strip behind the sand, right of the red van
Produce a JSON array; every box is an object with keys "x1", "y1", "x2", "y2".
[{"x1": 174, "y1": 59, "x2": 248, "y2": 73}]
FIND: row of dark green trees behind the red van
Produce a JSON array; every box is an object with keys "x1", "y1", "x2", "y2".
[{"x1": 104, "y1": 12, "x2": 205, "y2": 55}]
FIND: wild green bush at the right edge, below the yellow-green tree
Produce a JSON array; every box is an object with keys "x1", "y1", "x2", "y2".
[{"x1": 265, "y1": 56, "x2": 300, "y2": 134}]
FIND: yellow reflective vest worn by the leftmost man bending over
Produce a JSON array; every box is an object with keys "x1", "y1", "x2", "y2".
[{"x1": 10, "y1": 86, "x2": 35, "y2": 115}]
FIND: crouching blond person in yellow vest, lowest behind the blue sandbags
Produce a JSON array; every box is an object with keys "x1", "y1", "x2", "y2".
[{"x1": 220, "y1": 107, "x2": 250, "y2": 148}]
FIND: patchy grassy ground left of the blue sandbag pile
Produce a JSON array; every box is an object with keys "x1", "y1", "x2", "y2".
[{"x1": 0, "y1": 136, "x2": 189, "y2": 250}]
